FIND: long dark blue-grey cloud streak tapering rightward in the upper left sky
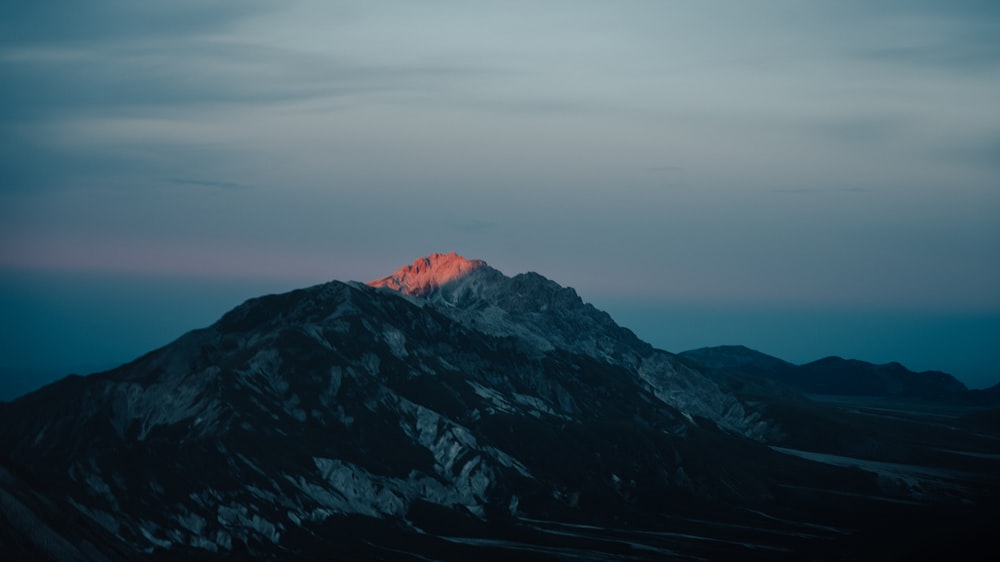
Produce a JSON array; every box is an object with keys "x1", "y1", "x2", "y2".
[{"x1": 0, "y1": 40, "x2": 476, "y2": 121}]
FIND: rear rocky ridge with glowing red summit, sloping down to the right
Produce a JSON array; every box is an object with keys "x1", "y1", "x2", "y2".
[{"x1": 368, "y1": 254, "x2": 768, "y2": 438}]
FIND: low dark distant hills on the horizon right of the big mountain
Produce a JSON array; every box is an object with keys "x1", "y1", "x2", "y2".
[{"x1": 680, "y1": 346, "x2": 969, "y2": 400}]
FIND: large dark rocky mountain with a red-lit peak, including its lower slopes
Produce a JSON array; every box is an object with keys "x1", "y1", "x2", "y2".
[{"x1": 0, "y1": 254, "x2": 997, "y2": 560}]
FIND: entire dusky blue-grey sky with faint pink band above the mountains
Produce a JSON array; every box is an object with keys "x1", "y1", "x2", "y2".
[{"x1": 0, "y1": 0, "x2": 1000, "y2": 399}]
